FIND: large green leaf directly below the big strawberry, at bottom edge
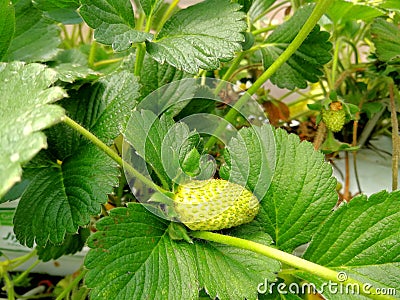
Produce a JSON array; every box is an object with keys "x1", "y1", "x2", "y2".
[{"x1": 85, "y1": 203, "x2": 280, "y2": 300}]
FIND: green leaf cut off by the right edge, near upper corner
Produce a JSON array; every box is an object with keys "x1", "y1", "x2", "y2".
[{"x1": 371, "y1": 19, "x2": 400, "y2": 63}]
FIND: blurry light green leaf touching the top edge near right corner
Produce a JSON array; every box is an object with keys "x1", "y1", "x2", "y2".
[{"x1": 327, "y1": 0, "x2": 384, "y2": 24}]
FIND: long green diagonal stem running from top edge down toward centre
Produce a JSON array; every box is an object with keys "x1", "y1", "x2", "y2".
[{"x1": 205, "y1": 0, "x2": 332, "y2": 149}]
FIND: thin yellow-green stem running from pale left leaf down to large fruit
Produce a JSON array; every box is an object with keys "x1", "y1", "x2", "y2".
[{"x1": 63, "y1": 116, "x2": 168, "y2": 194}]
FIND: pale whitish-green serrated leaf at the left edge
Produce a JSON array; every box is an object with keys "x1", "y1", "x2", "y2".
[{"x1": 0, "y1": 62, "x2": 65, "y2": 197}]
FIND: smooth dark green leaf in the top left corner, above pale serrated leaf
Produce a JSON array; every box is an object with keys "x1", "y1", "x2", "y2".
[{"x1": 4, "y1": 0, "x2": 61, "y2": 62}]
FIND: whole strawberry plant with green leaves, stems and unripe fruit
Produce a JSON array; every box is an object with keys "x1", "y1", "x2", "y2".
[{"x1": 0, "y1": 0, "x2": 400, "y2": 299}]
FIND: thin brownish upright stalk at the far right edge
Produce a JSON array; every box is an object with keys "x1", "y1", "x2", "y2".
[{"x1": 389, "y1": 81, "x2": 400, "y2": 191}]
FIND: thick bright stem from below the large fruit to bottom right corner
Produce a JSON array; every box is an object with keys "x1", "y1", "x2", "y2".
[{"x1": 191, "y1": 231, "x2": 393, "y2": 299}]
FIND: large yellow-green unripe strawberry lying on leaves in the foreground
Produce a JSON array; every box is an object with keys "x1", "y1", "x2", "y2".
[{"x1": 174, "y1": 179, "x2": 260, "y2": 230}]
